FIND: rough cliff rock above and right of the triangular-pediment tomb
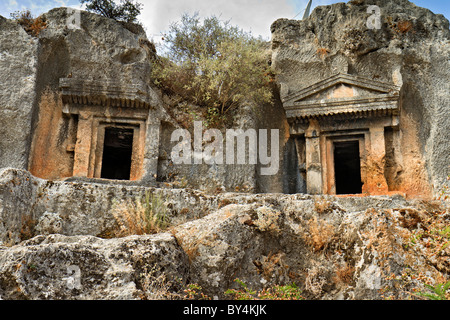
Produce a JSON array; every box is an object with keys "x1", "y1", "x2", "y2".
[{"x1": 271, "y1": 0, "x2": 450, "y2": 195}]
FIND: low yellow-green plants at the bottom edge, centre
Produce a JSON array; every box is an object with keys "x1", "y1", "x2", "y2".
[{"x1": 225, "y1": 279, "x2": 304, "y2": 300}]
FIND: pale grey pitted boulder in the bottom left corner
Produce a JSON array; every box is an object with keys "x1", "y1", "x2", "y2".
[{"x1": 0, "y1": 234, "x2": 189, "y2": 300}]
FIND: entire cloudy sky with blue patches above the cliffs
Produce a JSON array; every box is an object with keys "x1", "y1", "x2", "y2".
[{"x1": 0, "y1": 0, "x2": 450, "y2": 42}]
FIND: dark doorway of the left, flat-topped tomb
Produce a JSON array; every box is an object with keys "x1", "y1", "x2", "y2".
[{"x1": 101, "y1": 127, "x2": 134, "y2": 180}]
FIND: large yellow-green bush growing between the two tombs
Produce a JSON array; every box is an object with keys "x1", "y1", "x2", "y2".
[{"x1": 153, "y1": 15, "x2": 273, "y2": 116}]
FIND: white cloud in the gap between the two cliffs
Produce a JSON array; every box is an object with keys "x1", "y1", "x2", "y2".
[{"x1": 139, "y1": 0, "x2": 297, "y2": 41}]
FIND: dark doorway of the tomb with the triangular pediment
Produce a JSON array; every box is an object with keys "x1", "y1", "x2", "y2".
[{"x1": 334, "y1": 141, "x2": 362, "y2": 194}]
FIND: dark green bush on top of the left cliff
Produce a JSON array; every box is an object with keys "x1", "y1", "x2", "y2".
[{"x1": 80, "y1": 0, "x2": 142, "y2": 23}]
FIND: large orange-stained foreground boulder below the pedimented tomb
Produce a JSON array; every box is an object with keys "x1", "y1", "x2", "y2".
[{"x1": 173, "y1": 191, "x2": 450, "y2": 299}]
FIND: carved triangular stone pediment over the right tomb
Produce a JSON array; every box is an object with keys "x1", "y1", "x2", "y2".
[{"x1": 283, "y1": 73, "x2": 399, "y2": 106}]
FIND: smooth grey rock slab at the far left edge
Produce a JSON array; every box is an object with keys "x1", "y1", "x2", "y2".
[{"x1": 0, "y1": 16, "x2": 38, "y2": 169}]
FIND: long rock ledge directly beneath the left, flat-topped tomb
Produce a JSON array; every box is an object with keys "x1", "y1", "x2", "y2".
[{"x1": 0, "y1": 169, "x2": 219, "y2": 244}]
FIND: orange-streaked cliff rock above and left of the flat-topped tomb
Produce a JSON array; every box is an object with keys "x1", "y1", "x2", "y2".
[{"x1": 27, "y1": 8, "x2": 165, "y2": 179}]
